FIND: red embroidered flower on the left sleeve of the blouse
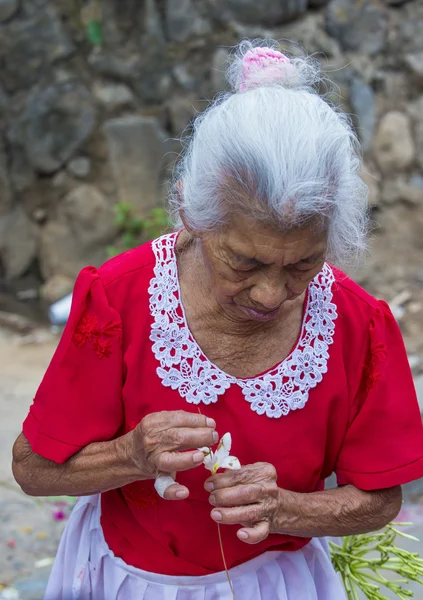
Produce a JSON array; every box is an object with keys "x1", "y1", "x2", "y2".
[{"x1": 72, "y1": 314, "x2": 122, "y2": 359}]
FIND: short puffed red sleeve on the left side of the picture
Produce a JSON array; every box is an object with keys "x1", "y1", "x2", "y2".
[{"x1": 23, "y1": 267, "x2": 123, "y2": 463}]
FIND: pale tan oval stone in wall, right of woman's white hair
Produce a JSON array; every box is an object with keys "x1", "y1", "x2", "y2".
[{"x1": 374, "y1": 111, "x2": 415, "y2": 173}]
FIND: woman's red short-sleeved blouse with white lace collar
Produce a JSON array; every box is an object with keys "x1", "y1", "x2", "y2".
[{"x1": 23, "y1": 234, "x2": 423, "y2": 575}]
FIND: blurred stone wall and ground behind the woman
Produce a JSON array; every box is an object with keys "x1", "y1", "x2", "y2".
[{"x1": 0, "y1": 0, "x2": 423, "y2": 600}]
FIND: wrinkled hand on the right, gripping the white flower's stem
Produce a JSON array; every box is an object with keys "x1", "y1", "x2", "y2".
[{"x1": 204, "y1": 463, "x2": 282, "y2": 544}]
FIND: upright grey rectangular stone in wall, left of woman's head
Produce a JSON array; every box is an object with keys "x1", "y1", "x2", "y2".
[{"x1": 104, "y1": 116, "x2": 164, "y2": 215}]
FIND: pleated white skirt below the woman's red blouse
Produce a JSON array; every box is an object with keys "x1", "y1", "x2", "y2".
[{"x1": 44, "y1": 495, "x2": 346, "y2": 600}]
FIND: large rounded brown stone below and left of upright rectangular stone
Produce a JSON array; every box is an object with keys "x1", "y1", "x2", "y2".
[{"x1": 40, "y1": 185, "x2": 117, "y2": 280}]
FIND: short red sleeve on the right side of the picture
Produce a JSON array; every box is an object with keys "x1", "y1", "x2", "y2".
[{"x1": 335, "y1": 301, "x2": 423, "y2": 490}]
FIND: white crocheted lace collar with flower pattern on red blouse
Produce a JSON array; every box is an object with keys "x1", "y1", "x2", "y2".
[{"x1": 148, "y1": 233, "x2": 337, "y2": 418}]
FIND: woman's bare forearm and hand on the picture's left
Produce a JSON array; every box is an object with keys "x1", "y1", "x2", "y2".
[{"x1": 12, "y1": 411, "x2": 218, "y2": 500}]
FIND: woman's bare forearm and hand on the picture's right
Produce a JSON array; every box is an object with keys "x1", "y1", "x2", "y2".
[{"x1": 205, "y1": 463, "x2": 402, "y2": 544}]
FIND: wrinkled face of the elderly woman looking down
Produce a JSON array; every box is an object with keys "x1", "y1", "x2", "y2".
[{"x1": 197, "y1": 215, "x2": 327, "y2": 322}]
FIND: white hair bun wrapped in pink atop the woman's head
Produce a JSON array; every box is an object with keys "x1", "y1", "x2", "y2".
[{"x1": 227, "y1": 40, "x2": 320, "y2": 92}]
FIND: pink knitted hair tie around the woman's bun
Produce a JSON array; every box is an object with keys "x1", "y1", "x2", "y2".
[{"x1": 239, "y1": 48, "x2": 291, "y2": 92}]
